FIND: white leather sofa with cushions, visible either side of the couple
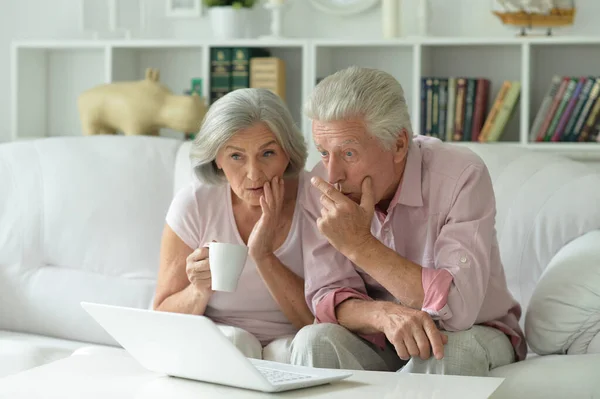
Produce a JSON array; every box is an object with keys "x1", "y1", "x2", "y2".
[{"x1": 0, "y1": 136, "x2": 600, "y2": 398}]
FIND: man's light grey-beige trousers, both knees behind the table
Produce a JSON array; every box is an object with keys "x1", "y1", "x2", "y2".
[{"x1": 291, "y1": 323, "x2": 515, "y2": 376}]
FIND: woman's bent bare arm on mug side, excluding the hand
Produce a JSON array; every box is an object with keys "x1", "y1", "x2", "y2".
[{"x1": 153, "y1": 225, "x2": 211, "y2": 315}]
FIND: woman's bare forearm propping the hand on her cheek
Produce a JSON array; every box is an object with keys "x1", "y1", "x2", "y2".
[{"x1": 255, "y1": 254, "x2": 314, "y2": 329}]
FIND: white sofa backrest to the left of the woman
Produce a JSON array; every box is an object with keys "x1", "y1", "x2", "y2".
[{"x1": 0, "y1": 136, "x2": 181, "y2": 345}]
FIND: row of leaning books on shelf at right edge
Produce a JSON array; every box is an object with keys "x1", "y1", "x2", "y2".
[{"x1": 529, "y1": 75, "x2": 600, "y2": 142}]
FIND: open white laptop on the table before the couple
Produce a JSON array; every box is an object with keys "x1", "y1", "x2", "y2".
[{"x1": 81, "y1": 302, "x2": 352, "y2": 392}]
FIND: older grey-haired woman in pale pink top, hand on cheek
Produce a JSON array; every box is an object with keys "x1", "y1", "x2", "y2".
[{"x1": 153, "y1": 89, "x2": 314, "y2": 362}]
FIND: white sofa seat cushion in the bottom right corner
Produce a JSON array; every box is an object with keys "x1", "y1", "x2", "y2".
[{"x1": 490, "y1": 354, "x2": 600, "y2": 399}]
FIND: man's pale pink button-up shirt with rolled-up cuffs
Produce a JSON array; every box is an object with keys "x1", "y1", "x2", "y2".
[{"x1": 303, "y1": 136, "x2": 527, "y2": 360}]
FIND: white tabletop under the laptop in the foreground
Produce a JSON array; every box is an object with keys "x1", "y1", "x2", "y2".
[{"x1": 0, "y1": 351, "x2": 504, "y2": 399}]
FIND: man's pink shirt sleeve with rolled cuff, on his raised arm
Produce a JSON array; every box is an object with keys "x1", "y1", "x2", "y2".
[{"x1": 422, "y1": 164, "x2": 496, "y2": 331}]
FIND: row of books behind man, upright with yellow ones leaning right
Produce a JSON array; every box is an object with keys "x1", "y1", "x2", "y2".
[{"x1": 421, "y1": 77, "x2": 521, "y2": 142}]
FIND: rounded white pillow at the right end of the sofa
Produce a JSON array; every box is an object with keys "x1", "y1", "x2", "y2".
[{"x1": 525, "y1": 230, "x2": 600, "y2": 355}]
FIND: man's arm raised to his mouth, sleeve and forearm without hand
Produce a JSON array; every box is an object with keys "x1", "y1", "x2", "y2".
[{"x1": 346, "y1": 164, "x2": 496, "y2": 331}]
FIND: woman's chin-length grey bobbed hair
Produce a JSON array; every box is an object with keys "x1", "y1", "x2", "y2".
[{"x1": 190, "y1": 89, "x2": 308, "y2": 184}]
